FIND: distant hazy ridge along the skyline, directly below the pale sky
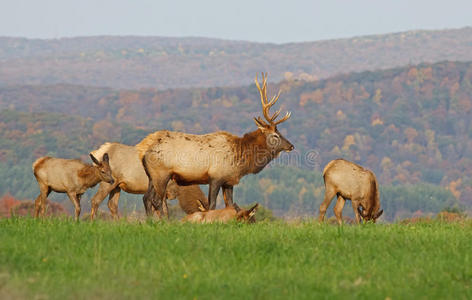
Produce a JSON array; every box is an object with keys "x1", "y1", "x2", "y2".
[{"x1": 0, "y1": 28, "x2": 472, "y2": 89}]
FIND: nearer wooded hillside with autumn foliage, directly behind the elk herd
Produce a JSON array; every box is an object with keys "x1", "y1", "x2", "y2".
[{"x1": 0, "y1": 62, "x2": 472, "y2": 218}]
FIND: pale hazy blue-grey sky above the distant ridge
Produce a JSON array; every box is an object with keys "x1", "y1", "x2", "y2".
[{"x1": 0, "y1": 0, "x2": 472, "y2": 43}]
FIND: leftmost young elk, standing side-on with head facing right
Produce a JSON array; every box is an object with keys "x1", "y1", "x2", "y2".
[{"x1": 33, "y1": 153, "x2": 113, "y2": 220}]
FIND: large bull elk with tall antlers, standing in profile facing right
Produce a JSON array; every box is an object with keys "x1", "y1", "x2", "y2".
[{"x1": 136, "y1": 74, "x2": 294, "y2": 214}]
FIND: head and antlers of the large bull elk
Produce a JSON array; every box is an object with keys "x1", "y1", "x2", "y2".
[{"x1": 254, "y1": 73, "x2": 294, "y2": 156}]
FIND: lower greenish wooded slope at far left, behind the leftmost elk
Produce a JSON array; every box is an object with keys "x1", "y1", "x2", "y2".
[{"x1": 0, "y1": 110, "x2": 146, "y2": 199}]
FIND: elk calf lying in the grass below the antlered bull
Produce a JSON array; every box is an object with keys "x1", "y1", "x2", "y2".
[{"x1": 184, "y1": 203, "x2": 259, "y2": 223}]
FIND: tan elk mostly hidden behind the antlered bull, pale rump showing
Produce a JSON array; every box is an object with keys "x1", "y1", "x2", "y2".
[{"x1": 90, "y1": 143, "x2": 208, "y2": 220}]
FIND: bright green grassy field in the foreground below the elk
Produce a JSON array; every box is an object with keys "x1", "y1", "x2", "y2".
[{"x1": 0, "y1": 218, "x2": 472, "y2": 299}]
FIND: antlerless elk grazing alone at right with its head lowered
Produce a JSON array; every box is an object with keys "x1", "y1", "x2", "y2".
[{"x1": 319, "y1": 159, "x2": 383, "y2": 224}]
